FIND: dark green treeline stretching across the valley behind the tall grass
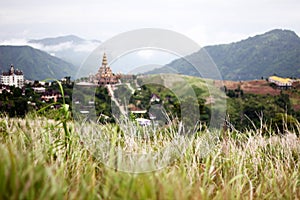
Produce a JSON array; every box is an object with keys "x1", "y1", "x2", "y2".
[{"x1": 0, "y1": 79, "x2": 300, "y2": 132}]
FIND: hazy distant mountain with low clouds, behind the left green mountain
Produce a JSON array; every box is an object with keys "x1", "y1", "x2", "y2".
[{"x1": 28, "y1": 35, "x2": 101, "y2": 67}]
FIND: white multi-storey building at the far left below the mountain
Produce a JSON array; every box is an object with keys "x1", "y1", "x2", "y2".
[{"x1": 1, "y1": 65, "x2": 24, "y2": 88}]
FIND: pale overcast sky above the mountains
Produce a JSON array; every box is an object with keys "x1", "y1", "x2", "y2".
[{"x1": 0, "y1": 0, "x2": 300, "y2": 46}]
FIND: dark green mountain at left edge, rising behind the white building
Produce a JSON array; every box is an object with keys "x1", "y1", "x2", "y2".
[{"x1": 0, "y1": 46, "x2": 76, "y2": 80}]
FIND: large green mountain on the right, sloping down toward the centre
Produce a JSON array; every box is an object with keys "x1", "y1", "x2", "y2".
[{"x1": 150, "y1": 29, "x2": 300, "y2": 80}]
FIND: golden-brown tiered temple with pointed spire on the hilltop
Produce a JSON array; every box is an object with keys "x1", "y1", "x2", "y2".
[{"x1": 89, "y1": 53, "x2": 120, "y2": 86}]
